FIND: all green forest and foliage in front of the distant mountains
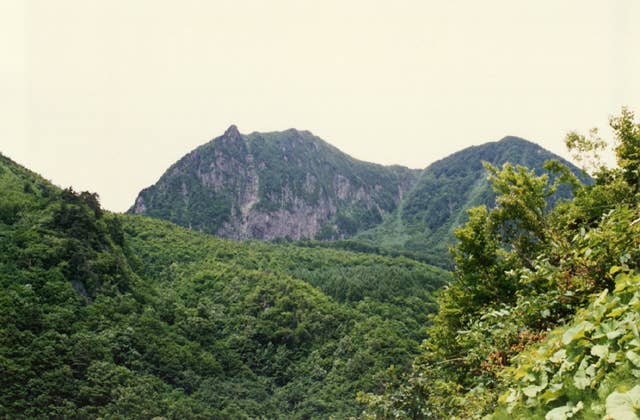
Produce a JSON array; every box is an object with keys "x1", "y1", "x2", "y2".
[{"x1": 0, "y1": 109, "x2": 640, "y2": 419}]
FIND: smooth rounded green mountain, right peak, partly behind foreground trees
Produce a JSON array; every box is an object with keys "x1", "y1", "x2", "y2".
[{"x1": 358, "y1": 136, "x2": 589, "y2": 264}]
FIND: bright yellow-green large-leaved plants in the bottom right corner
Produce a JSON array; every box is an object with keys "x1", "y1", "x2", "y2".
[{"x1": 500, "y1": 274, "x2": 640, "y2": 418}]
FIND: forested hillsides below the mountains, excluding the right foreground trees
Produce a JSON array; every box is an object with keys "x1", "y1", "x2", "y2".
[{"x1": 0, "y1": 155, "x2": 449, "y2": 419}]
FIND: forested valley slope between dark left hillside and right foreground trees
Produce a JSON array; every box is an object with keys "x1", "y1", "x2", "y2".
[{"x1": 125, "y1": 217, "x2": 448, "y2": 417}]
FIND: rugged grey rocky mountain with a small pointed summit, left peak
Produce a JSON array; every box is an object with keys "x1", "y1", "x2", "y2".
[{"x1": 130, "y1": 126, "x2": 420, "y2": 239}]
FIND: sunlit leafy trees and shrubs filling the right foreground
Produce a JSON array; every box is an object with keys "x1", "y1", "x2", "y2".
[{"x1": 359, "y1": 110, "x2": 640, "y2": 419}]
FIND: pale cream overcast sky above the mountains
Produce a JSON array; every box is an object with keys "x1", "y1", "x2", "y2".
[{"x1": 0, "y1": 0, "x2": 640, "y2": 211}]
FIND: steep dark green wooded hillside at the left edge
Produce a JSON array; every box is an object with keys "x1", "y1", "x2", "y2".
[{"x1": 0, "y1": 156, "x2": 179, "y2": 418}]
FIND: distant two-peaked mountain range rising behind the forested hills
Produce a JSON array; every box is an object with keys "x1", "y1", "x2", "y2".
[{"x1": 131, "y1": 127, "x2": 588, "y2": 268}]
